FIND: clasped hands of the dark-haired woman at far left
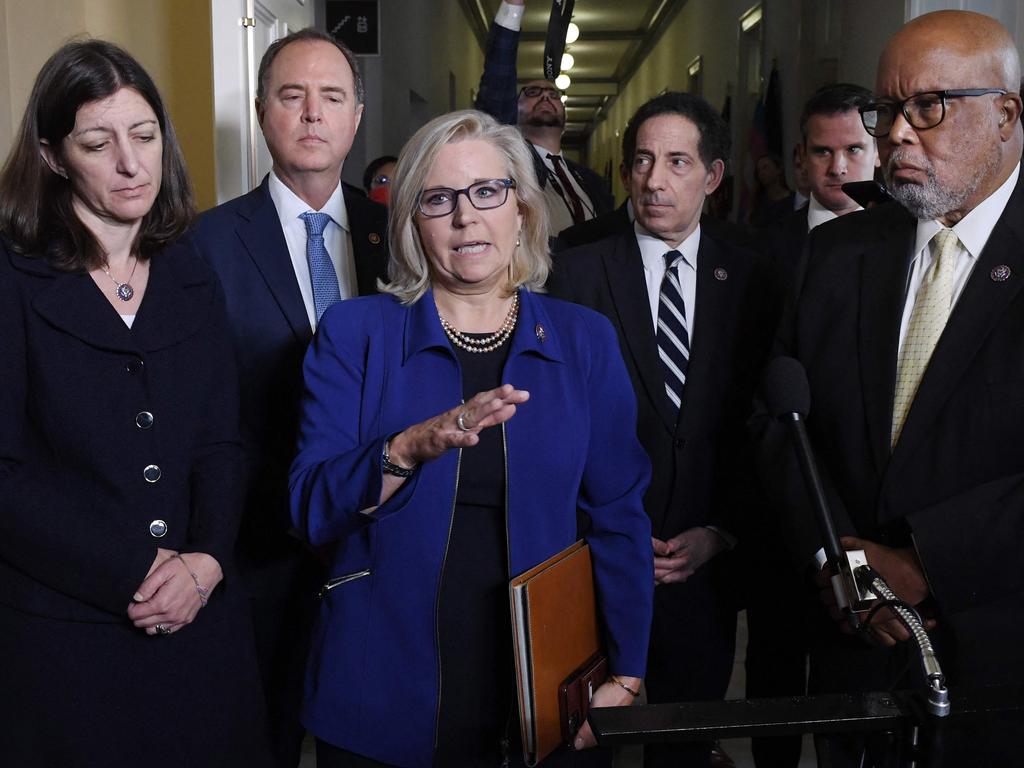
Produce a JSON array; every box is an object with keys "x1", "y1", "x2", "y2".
[{"x1": 128, "y1": 549, "x2": 224, "y2": 635}]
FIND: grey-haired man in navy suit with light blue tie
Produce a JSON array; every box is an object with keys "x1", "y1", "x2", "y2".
[{"x1": 194, "y1": 30, "x2": 387, "y2": 768}]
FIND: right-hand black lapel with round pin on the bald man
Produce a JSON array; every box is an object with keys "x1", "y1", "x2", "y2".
[{"x1": 892, "y1": 184, "x2": 1024, "y2": 469}]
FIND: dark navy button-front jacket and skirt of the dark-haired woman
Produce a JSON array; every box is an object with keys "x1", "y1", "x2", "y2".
[{"x1": 0, "y1": 237, "x2": 263, "y2": 768}]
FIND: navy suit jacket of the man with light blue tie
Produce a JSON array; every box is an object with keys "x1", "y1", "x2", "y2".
[{"x1": 193, "y1": 178, "x2": 387, "y2": 564}]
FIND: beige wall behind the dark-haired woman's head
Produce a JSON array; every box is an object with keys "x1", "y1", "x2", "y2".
[{"x1": 0, "y1": 0, "x2": 215, "y2": 210}]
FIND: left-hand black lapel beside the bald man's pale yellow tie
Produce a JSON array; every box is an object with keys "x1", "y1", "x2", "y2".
[{"x1": 858, "y1": 209, "x2": 916, "y2": 475}]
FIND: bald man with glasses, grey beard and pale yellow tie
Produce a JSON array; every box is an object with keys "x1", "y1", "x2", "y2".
[{"x1": 764, "y1": 11, "x2": 1024, "y2": 766}]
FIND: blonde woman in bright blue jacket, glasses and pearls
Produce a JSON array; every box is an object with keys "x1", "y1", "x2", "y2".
[{"x1": 291, "y1": 112, "x2": 653, "y2": 766}]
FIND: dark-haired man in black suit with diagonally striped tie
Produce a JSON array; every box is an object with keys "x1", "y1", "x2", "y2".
[{"x1": 550, "y1": 92, "x2": 775, "y2": 768}]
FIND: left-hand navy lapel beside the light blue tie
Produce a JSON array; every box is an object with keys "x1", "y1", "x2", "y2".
[{"x1": 237, "y1": 177, "x2": 312, "y2": 342}]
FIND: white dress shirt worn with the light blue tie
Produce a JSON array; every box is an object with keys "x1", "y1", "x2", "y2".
[{"x1": 268, "y1": 171, "x2": 358, "y2": 330}]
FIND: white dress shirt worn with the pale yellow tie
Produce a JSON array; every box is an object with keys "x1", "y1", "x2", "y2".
[{"x1": 899, "y1": 163, "x2": 1021, "y2": 351}]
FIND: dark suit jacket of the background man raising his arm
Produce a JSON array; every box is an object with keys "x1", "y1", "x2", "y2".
[{"x1": 475, "y1": 24, "x2": 615, "y2": 216}]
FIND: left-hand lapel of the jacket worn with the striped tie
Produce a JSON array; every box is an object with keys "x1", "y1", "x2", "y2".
[{"x1": 603, "y1": 229, "x2": 676, "y2": 431}]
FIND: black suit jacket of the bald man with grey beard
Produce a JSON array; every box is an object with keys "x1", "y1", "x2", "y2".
[{"x1": 765, "y1": 182, "x2": 1024, "y2": 683}]
